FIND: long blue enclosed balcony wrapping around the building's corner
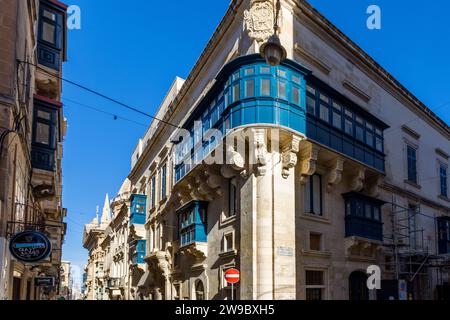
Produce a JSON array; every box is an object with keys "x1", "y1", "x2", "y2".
[{"x1": 174, "y1": 55, "x2": 388, "y2": 183}]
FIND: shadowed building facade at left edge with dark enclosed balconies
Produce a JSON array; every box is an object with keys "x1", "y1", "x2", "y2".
[{"x1": 0, "y1": 0, "x2": 67, "y2": 300}]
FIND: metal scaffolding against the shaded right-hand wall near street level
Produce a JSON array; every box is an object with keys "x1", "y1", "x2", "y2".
[{"x1": 383, "y1": 195, "x2": 450, "y2": 300}]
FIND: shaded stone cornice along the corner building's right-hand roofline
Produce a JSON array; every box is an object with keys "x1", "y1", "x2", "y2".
[{"x1": 295, "y1": 0, "x2": 450, "y2": 138}]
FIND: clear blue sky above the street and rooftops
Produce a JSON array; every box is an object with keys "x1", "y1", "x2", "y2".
[{"x1": 63, "y1": 0, "x2": 450, "y2": 282}]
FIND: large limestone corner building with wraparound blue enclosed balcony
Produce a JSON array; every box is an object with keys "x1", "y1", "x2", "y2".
[{"x1": 118, "y1": 0, "x2": 450, "y2": 300}]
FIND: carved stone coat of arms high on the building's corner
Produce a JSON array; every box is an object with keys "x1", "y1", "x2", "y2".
[{"x1": 244, "y1": 0, "x2": 274, "y2": 42}]
